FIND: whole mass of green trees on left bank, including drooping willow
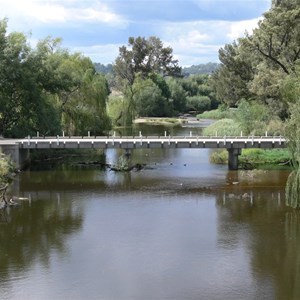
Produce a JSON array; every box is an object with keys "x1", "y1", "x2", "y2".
[{"x1": 0, "y1": 19, "x2": 110, "y2": 137}]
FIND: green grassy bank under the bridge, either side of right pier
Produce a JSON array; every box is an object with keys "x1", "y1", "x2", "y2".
[{"x1": 210, "y1": 149, "x2": 291, "y2": 169}]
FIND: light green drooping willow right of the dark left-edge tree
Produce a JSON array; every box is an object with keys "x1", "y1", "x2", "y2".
[{"x1": 58, "y1": 53, "x2": 110, "y2": 135}]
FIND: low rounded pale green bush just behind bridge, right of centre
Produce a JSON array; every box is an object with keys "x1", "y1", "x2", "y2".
[{"x1": 203, "y1": 119, "x2": 241, "y2": 136}]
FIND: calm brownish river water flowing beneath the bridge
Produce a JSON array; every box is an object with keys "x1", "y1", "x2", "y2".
[{"x1": 0, "y1": 120, "x2": 300, "y2": 300}]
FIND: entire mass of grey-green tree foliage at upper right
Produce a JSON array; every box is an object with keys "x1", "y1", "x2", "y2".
[{"x1": 212, "y1": 0, "x2": 300, "y2": 119}]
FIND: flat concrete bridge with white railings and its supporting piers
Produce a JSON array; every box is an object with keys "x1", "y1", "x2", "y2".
[{"x1": 0, "y1": 134, "x2": 286, "y2": 170}]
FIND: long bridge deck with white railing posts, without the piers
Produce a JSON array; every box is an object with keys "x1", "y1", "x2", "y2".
[{"x1": 11, "y1": 136, "x2": 286, "y2": 149}]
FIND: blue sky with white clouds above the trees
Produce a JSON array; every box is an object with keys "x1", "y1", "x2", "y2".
[{"x1": 0, "y1": 0, "x2": 271, "y2": 67}]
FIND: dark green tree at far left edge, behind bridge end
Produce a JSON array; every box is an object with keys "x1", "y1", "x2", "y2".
[{"x1": 0, "y1": 20, "x2": 59, "y2": 136}]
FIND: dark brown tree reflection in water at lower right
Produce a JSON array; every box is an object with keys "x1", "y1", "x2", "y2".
[{"x1": 217, "y1": 188, "x2": 300, "y2": 300}]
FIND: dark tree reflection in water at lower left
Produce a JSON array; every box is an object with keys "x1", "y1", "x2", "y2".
[{"x1": 0, "y1": 196, "x2": 83, "y2": 299}]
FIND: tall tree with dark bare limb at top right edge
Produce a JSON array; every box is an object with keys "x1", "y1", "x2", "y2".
[{"x1": 247, "y1": 0, "x2": 300, "y2": 118}]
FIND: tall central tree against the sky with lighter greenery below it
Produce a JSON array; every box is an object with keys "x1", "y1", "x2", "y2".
[{"x1": 114, "y1": 36, "x2": 181, "y2": 125}]
